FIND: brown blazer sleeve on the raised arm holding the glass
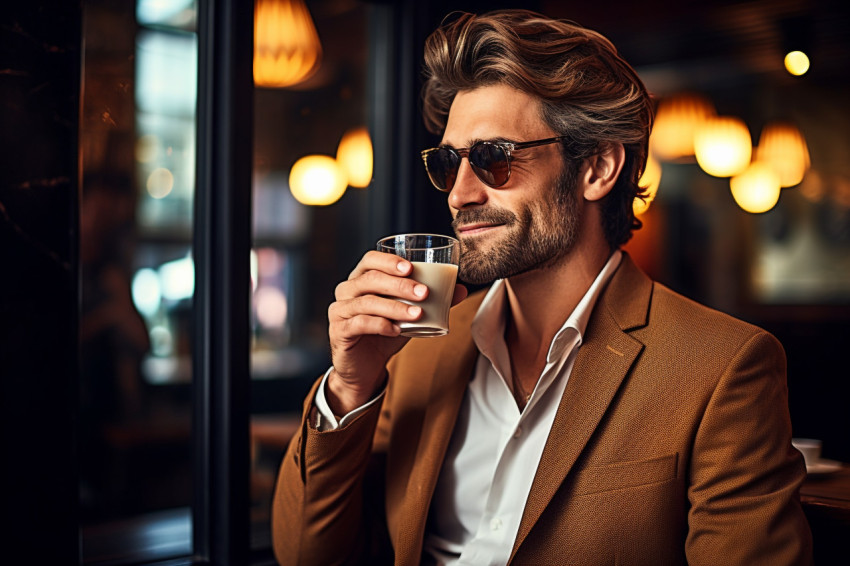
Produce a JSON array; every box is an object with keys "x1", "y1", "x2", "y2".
[{"x1": 272, "y1": 380, "x2": 388, "y2": 566}]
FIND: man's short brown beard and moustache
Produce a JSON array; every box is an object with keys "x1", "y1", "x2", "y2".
[{"x1": 452, "y1": 164, "x2": 581, "y2": 285}]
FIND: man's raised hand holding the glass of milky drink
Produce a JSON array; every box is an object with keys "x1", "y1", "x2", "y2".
[{"x1": 327, "y1": 251, "x2": 467, "y2": 415}]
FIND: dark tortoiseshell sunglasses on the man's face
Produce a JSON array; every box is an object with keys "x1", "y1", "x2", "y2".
[{"x1": 422, "y1": 136, "x2": 567, "y2": 192}]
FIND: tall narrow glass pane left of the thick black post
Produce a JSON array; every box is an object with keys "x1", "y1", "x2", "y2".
[{"x1": 79, "y1": 0, "x2": 197, "y2": 562}]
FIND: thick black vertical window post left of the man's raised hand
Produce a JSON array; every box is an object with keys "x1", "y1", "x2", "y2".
[{"x1": 192, "y1": 0, "x2": 254, "y2": 564}]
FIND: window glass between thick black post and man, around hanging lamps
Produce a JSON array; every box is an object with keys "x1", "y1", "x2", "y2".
[{"x1": 251, "y1": 1, "x2": 372, "y2": 546}]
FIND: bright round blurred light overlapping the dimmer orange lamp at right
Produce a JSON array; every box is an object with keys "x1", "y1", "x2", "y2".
[{"x1": 694, "y1": 116, "x2": 753, "y2": 177}]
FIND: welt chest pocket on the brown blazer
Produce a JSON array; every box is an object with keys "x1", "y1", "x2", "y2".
[{"x1": 573, "y1": 453, "x2": 679, "y2": 496}]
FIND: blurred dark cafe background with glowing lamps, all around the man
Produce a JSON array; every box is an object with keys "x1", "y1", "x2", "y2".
[{"x1": 0, "y1": 0, "x2": 850, "y2": 566}]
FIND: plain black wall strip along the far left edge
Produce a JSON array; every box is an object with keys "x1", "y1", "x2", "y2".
[{"x1": 0, "y1": 0, "x2": 81, "y2": 564}]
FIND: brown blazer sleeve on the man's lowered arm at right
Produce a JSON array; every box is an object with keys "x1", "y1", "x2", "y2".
[{"x1": 685, "y1": 331, "x2": 812, "y2": 566}]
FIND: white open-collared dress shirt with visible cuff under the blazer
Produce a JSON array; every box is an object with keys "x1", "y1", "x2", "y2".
[{"x1": 315, "y1": 251, "x2": 622, "y2": 566}]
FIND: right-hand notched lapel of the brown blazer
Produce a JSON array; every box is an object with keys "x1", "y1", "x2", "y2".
[{"x1": 511, "y1": 253, "x2": 652, "y2": 558}]
